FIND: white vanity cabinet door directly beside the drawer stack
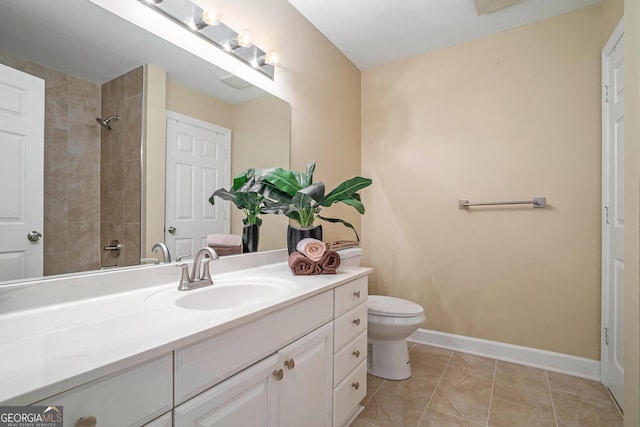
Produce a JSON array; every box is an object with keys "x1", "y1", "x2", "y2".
[{"x1": 278, "y1": 323, "x2": 333, "y2": 427}]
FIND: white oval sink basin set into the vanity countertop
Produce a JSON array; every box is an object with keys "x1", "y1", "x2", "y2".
[{"x1": 148, "y1": 277, "x2": 294, "y2": 310}]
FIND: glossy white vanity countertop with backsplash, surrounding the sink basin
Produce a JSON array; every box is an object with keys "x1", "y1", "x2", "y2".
[{"x1": 0, "y1": 252, "x2": 371, "y2": 405}]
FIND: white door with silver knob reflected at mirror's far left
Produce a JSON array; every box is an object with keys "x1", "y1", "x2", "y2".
[{"x1": 0, "y1": 64, "x2": 44, "y2": 281}]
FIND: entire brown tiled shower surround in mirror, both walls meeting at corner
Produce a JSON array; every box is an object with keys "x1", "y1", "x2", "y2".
[{"x1": 0, "y1": 52, "x2": 143, "y2": 275}]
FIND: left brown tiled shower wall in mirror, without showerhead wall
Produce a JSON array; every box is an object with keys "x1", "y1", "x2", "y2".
[{"x1": 0, "y1": 52, "x2": 100, "y2": 275}]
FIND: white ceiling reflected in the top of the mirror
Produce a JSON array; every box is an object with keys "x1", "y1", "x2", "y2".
[{"x1": 0, "y1": 0, "x2": 265, "y2": 104}]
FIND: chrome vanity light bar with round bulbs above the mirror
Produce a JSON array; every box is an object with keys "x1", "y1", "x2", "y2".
[{"x1": 138, "y1": 0, "x2": 280, "y2": 80}]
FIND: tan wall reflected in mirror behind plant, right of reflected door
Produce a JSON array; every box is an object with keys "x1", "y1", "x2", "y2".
[{"x1": 231, "y1": 96, "x2": 291, "y2": 251}]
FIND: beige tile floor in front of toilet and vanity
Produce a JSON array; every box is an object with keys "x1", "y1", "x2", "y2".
[{"x1": 351, "y1": 344, "x2": 622, "y2": 427}]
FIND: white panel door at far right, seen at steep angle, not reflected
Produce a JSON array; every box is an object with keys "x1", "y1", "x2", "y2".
[{"x1": 601, "y1": 21, "x2": 624, "y2": 407}]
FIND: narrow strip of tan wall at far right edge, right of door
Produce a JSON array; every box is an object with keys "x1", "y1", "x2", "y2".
[{"x1": 624, "y1": 0, "x2": 640, "y2": 427}]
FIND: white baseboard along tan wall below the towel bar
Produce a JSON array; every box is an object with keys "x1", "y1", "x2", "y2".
[{"x1": 407, "y1": 329, "x2": 600, "y2": 381}]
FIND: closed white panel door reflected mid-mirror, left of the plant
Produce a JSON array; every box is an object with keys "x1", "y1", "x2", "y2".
[{"x1": 165, "y1": 111, "x2": 231, "y2": 257}]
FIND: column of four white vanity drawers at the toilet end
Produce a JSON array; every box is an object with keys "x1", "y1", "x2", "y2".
[{"x1": 333, "y1": 276, "x2": 368, "y2": 427}]
